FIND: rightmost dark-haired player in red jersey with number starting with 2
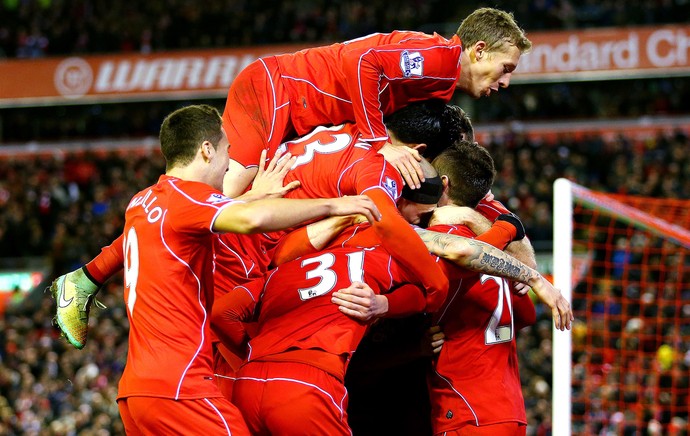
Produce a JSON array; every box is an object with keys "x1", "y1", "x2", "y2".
[{"x1": 428, "y1": 142, "x2": 536, "y2": 436}]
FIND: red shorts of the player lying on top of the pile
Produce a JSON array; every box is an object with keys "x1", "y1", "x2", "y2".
[{"x1": 223, "y1": 56, "x2": 296, "y2": 168}]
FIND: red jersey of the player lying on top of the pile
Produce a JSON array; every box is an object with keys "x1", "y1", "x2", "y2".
[{"x1": 275, "y1": 31, "x2": 462, "y2": 148}]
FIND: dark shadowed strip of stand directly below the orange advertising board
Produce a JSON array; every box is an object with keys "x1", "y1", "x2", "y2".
[{"x1": 0, "y1": 77, "x2": 690, "y2": 142}]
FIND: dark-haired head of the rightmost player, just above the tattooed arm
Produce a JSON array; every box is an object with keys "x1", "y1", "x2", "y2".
[{"x1": 432, "y1": 141, "x2": 496, "y2": 207}]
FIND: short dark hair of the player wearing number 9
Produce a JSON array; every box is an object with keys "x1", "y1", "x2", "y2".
[{"x1": 159, "y1": 104, "x2": 223, "y2": 170}]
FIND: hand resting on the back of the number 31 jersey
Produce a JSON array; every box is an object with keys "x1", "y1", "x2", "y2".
[{"x1": 331, "y1": 282, "x2": 388, "y2": 322}]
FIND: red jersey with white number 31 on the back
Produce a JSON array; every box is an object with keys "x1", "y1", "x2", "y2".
[{"x1": 238, "y1": 247, "x2": 418, "y2": 372}]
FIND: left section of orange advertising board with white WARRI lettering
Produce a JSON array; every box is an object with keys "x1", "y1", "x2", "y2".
[{"x1": 0, "y1": 46, "x2": 303, "y2": 107}]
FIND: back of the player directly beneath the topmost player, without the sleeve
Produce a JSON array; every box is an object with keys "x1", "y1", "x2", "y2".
[{"x1": 281, "y1": 124, "x2": 402, "y2": 202}]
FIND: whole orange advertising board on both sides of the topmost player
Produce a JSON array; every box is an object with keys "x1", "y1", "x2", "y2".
[{"x1": 0, "y1": 25, "x2": 690, "y2": 107}]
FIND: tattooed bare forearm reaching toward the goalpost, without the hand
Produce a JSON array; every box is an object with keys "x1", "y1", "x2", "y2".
[{"x1": 417, "y1": 229, "x2": 539, "y2": 283}]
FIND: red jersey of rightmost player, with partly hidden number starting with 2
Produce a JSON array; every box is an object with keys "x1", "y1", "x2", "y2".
[{"x1": 429, "y1": 226, "x2": 531, "y2": 434}]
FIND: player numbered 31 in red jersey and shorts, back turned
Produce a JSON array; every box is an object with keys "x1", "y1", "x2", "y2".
[{"x1": 211, "y1": 238, "x2": 424, "y2": 435}]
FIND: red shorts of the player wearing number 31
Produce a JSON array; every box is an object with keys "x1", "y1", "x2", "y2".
[{"x1": 233, "y1": 362, "x2": 351, "y2": 436}]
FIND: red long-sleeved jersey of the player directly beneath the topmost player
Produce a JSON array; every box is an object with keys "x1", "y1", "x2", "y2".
[{"x1": 282, "y1": 124, "x2": 448, "y2": 310}]
